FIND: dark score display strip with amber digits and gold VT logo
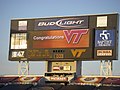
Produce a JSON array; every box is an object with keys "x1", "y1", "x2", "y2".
[{"x1": 27, "y1": 49, "x2": 92, "y2": 61}]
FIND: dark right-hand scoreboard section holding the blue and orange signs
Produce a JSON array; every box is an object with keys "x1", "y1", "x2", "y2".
[{"x1": 94, "y1": 29, "x2": 117, "y2": 60}]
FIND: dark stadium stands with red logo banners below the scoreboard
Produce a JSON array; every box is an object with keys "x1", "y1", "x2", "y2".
[{"x1": 0, "y1": 76, "x2": 120, "y2": 90}]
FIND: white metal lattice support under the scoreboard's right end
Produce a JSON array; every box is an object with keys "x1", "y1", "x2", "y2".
[{"x1": 100, "y1": 60, "x2": 112, "y2": 76}]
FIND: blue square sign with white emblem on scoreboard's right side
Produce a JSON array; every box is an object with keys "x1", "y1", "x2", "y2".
[{"x1": 95, "y1": 30, "x2": 115, "y2": 47}]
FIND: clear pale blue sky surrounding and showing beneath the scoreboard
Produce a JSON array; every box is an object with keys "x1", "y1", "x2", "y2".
[{"x1": 0, "y1": 0, "x2": 120, "y2": 75}]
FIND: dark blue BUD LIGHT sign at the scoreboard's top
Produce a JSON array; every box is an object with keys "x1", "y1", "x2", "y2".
[{"x1": 34, "y1": 17, "x2": 88, "y2": 30}]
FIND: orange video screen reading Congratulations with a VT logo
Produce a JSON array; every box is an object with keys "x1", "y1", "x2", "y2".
[{"x1": 29, "y1": 29, "x2": 89, "y2": 48}]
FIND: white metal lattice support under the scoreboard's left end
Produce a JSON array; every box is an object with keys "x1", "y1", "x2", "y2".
[{"x1": 18, "y1": 61, "x2": 29, "y2": 75}]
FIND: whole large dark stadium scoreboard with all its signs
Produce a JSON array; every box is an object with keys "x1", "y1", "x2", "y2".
[{"x1": 9, "y1": 13, "x2": 119, "y2": 61}]
